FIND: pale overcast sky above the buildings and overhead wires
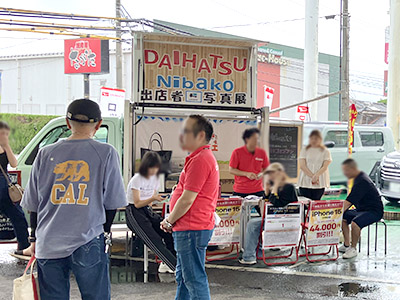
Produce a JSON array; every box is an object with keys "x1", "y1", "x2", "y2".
[{"x1": 0, "y1": 0, "x2": 390, "y2": 101}]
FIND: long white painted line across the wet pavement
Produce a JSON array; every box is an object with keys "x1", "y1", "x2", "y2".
[{"x1": 206, "y1": 264, "x2": 400, "y2": 284}]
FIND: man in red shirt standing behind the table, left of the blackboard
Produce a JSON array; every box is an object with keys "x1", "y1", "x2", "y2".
[{"x1": 229, "y1": 128, "x2": 269, "y2": 203}]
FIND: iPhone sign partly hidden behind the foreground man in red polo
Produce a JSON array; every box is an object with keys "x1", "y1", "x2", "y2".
[{"x1": 209, "y1": 198, "x2": 242, "y2": 245}]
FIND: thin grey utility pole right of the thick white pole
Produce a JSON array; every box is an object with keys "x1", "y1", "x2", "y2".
[{"x1": 340, "y1": 0, "x2": 350, "y2": 122}]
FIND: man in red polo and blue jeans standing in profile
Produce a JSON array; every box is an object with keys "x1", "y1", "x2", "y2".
[{"x1": 161, "y1": 115, "x2": 219, "y2": 300}]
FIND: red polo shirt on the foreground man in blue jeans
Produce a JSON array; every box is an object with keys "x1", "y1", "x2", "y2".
[{"x1": 171, "y1": 145, "x2": 219, "y2": 231}]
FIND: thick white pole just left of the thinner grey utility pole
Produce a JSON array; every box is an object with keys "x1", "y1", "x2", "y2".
[{"x1": 303, "y1": 0, "x2": 319, "y2": 121}]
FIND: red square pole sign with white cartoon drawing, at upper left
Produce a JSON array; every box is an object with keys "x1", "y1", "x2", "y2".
[{"x1": 64, "y1": 38, "x2": 110, "y2": 74}]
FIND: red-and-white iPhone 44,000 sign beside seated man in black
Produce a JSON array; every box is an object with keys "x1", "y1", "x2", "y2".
[{"x1": 307, "y1": 200, "x2": 343, "y2": 246}]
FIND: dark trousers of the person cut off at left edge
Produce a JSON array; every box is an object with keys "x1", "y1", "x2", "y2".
[{"x1": 0, "y1": 173, "x2": 30, "y2": 250}]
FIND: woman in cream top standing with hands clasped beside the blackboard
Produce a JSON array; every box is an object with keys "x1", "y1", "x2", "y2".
[{"x1": 298, "y1": 130, "x2": 332, "y2": 200}]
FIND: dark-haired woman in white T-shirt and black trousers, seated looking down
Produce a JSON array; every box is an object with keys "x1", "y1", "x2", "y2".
[{"x1": 127, "y1": 151, "x2": 176, "y2": 273}]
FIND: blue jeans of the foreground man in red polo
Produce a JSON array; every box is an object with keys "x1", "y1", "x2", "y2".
[{"x1": 173, "y1": 230, "x2": 213, "y2": 300}]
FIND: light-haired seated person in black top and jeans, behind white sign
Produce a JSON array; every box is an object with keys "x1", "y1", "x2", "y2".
[{"x1": 239, "y1": 163, "x2": 297, "y2": 265}]
